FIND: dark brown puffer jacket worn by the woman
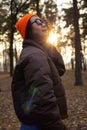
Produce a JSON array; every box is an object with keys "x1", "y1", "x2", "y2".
[{"x1": 12, "y1": 41, "x2": 66, "y2": 130}]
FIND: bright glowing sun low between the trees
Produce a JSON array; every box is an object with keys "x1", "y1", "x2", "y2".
[{"x1": 47, "y1": 31, "x2": 58, "y2": 46}]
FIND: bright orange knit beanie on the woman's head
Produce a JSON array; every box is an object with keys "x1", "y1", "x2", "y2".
[{"x1": 15, "y1": 14, "x2": 37, "y2": 39}]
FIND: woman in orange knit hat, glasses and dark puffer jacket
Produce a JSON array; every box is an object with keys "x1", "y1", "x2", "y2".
[{"x1": 12, "y1": 14, "x2": 67, "y2": 130}]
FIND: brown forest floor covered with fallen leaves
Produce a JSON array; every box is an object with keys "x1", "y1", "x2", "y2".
[{"x1": 0, "y1": 71, "x2": 87, "y2": 130}]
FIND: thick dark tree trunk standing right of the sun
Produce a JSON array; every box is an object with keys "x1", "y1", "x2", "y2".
[{"x1": 73, "y1": 0, "x2": 83, "y2": 86}]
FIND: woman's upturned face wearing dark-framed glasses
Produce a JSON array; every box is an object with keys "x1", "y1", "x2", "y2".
[{"x1": 30, "y1": 16, "x2": 48, "y2": 39}]
